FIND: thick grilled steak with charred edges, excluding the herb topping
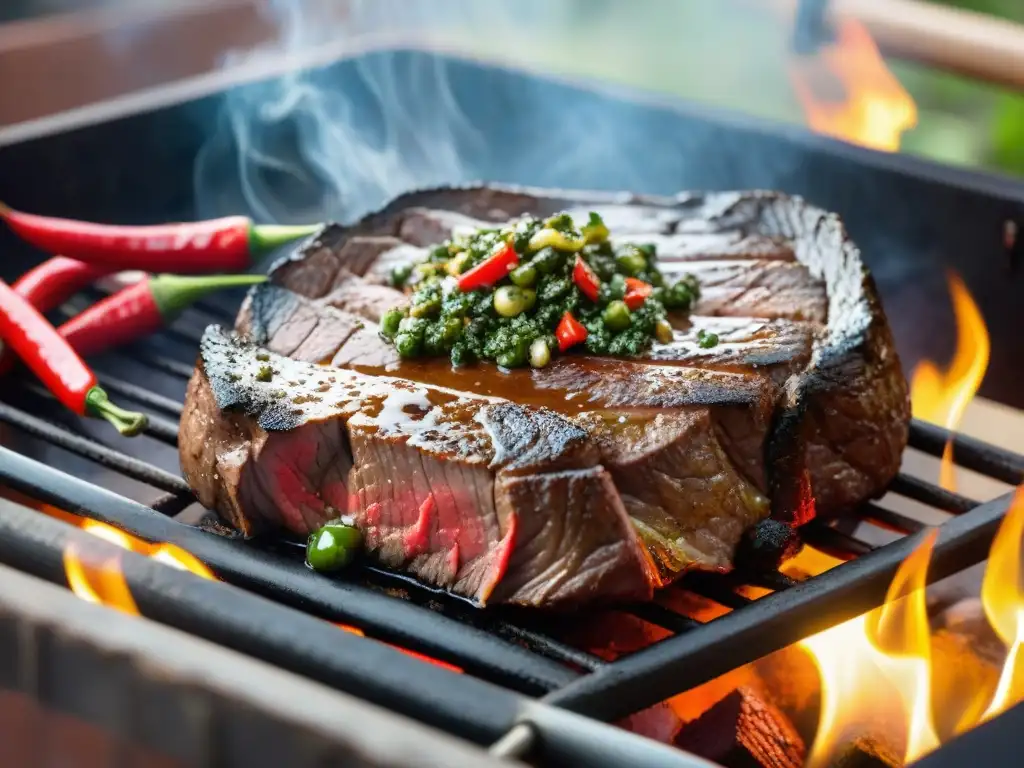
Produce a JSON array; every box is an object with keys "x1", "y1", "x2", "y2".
[{"x1": 180, "y1": 188, "x2": 908, "y2": 605}]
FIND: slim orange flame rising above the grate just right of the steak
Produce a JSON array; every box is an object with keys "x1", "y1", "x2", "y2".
[{"x1": 910, "y1": 272, "x2": 990, "y2": 490}]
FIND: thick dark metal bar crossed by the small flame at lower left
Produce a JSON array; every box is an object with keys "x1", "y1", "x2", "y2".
[{"x1": 0, "y1": 499, "x2": 523, "y2": 743}]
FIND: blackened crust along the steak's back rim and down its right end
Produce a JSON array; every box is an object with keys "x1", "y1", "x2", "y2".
[{"x1": 271, "y1": 185, "x2": 910, "y2": 522}]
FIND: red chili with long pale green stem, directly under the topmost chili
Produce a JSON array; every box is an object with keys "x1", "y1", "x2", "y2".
[{"x1": 56, "y1": 274, "x2": 266, "y2": 360}]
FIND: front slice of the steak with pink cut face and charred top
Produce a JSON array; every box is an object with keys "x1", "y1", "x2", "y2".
[{"x1": 181, "y1": 327, "x2": 655, "y2": 604}]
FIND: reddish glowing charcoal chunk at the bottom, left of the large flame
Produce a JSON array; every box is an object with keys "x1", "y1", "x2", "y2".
[{"x1": 676, "y1": 686, "x2": 806, "y2": 768}]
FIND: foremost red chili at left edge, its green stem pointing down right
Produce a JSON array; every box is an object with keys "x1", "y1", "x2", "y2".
[{"x1": 0, "y1": 281, "x2": 147, "y2": 435}]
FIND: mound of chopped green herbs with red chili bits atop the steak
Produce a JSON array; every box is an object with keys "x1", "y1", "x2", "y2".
[{"x1": 380, "y1": 213, "x2": 699, "y2": 368}]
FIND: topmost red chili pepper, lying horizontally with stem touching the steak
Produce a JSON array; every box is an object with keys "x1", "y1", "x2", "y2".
[{"x1": 0, "y1": 204, "x2": 319, "y2": 272}]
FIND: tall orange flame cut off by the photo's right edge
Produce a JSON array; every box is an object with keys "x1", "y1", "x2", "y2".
[{"x1": 981, "y1": 486, "x2": 1024, "y2": 720}]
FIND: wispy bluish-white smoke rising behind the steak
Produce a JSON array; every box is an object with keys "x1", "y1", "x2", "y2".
[{"x1": 196, "y1": 0, "x2": 791, "y2": 227}]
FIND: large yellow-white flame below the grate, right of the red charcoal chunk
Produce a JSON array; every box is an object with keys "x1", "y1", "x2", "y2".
[{"x1": 800, "y1": 530, "x2": 939, "y2": 768}]
